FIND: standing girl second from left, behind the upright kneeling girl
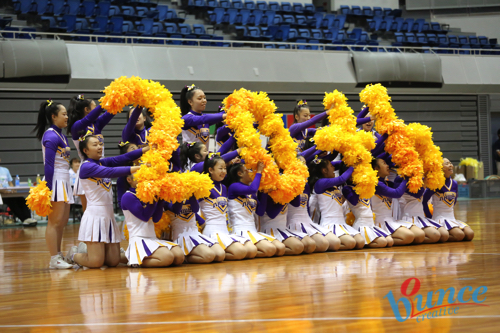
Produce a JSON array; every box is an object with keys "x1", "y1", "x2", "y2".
[{"x1": 66, "y1": 95, "x2": 114, "y2": 212}]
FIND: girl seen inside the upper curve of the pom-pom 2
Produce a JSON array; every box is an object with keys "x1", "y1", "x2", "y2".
[{"x1": 122, "y1": 106, "x2": 151, "y2": 148}]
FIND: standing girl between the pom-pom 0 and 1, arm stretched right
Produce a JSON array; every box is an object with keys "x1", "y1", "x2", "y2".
[{"x1": 289, "y1": 101, "x2": 329, "y2": 151}]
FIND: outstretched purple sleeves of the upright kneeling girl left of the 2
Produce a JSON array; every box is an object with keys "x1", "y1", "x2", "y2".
[{"x1": 80, "y1": 149, "x2": 142, "y2": 179}]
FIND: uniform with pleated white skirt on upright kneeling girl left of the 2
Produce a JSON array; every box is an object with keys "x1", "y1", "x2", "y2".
[{"x1": 78, "y1": 149, "x2": 142, "y2": 243}]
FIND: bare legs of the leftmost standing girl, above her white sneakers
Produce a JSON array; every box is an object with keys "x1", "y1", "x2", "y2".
[{"x1": 45, "y1": 201, "x2": 69, "y2": 256}]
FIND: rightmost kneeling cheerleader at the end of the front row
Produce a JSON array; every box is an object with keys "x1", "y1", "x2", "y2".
[{"x1": 422, "y1": 158, "x2": 474, "y2": 242}]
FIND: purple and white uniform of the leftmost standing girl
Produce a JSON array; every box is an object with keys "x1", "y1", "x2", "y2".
[{"x1": 42, "y1": 125, "x2": 74, "y2": 204}]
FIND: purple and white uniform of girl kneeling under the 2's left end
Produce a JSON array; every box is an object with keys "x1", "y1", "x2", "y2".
[{"x1": 121, "y1": 188, "x2": 177, "y2": 266}]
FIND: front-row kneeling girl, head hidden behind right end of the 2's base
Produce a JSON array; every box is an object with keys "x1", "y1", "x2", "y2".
[{"x1": 165, "y1": 196, "x2": 225, "y2": 264}]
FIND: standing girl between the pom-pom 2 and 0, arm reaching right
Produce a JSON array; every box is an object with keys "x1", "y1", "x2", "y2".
[{"x1": 181, "y1": 84, "x2": 226, "y2": 149}]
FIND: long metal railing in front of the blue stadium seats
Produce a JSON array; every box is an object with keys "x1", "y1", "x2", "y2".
[{"x1": 0, "y1": 30, "x2": 500, "y2": 56}]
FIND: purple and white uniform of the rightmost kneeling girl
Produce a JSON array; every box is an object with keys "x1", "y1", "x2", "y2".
[{"x1": 422, "y1": 178, "x2": 469, "y2": 230}]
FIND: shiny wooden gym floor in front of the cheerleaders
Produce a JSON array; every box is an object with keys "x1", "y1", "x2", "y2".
[{"x1": 0, "y1": 199, "x2": 500, "y2": 332}]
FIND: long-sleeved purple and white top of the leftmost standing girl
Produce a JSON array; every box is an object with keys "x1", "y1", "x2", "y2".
[{"x1": 42, "y1": 125, "x2": 70, "y2": 190}]
